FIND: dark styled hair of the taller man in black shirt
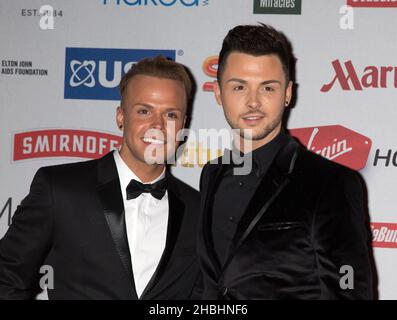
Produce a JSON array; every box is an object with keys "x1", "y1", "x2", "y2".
[{"x1": 217, "y1": 23, "x2": 293, "y2": 85}]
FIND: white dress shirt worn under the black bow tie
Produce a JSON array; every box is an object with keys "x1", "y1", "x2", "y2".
[{"x1": 113, "y1": 150, "x2": 168, "y2": 297}]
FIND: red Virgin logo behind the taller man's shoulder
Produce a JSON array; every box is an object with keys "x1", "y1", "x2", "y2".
[{"x1": 290, "y1": 125, "x2": 372, "y2": 170}]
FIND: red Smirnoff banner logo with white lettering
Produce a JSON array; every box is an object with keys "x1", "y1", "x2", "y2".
[{"x1": 13, "y1": 129, "x2": 122, "y2": 161}]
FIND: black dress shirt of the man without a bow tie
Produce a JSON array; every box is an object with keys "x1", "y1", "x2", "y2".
[{"x1": 212, "y1": 131, "x2": 288, "y2": 265}]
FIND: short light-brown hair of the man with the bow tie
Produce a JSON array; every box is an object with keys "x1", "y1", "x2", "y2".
[{"x1": 119, "y1": 56, "x2": 194, "y2": 107}]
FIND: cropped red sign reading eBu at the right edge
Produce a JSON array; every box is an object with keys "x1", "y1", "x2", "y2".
[{"x1": 371, "y1": 222, "x2": 397, "y2": 248}]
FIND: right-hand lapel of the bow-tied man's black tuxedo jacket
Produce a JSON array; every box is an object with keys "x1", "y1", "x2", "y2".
[{"x1": 141, "y1": 171, "x2": 185, "y2": 299}]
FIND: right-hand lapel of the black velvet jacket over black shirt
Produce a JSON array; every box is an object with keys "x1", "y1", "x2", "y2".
[{"x1": 223, "y1": 138, "x2": 299, "y2": 270}]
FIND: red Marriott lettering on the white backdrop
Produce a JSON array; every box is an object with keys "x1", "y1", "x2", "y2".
[{"x1": 321, "y1": 60, "x2": 397, "y2": 92}]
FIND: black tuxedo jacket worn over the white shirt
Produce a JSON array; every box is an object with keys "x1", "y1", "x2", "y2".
[{"x1": 0, "y1": 153, "x2": 200, "y2": 299}]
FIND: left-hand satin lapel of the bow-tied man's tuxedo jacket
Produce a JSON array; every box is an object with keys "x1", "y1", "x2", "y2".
[{"x1": 97, "y1": 153, "x2": 137, "y2": 297}]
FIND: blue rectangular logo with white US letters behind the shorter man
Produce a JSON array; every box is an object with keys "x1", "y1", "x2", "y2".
[{"x1": 64, "y1": 48, "x2": 175, "y2": 100}]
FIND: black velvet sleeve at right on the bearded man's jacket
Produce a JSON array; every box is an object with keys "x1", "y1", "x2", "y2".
[{"x1": 312, "y1": 169, "x2": 373, "y2": 299}]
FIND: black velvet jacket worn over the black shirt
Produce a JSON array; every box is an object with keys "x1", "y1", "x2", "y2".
[{"x1": 198, "y1": 138, "x2": 373, "y2": 299}]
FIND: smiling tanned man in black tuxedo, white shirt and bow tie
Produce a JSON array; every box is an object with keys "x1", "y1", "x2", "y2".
[{"x1": 0, "y1": 57, "x2": 199, "y2": 300}]
